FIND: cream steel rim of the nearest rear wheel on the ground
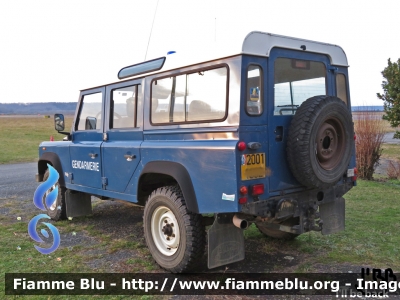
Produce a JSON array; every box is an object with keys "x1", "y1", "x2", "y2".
[{"x1": 150, "y1": 206, "x2": 180, "y2": 256}]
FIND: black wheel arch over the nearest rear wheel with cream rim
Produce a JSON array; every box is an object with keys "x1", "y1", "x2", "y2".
[{"x1": 137, "y1": 161, "x2": 199, "y2": 213}]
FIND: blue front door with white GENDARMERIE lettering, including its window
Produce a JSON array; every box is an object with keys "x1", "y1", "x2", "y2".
[{"x1": 69, "y1": 87, "x2": 105, "y2": 189}]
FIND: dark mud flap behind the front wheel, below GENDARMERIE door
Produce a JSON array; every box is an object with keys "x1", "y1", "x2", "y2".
[{"x1": 65, "y1": 190, "x2": 92, "y2": 217}]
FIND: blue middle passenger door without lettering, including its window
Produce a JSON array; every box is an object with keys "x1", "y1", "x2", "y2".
[{"x1": 101, "y1": 80, "x2": 143, "y2": 193}]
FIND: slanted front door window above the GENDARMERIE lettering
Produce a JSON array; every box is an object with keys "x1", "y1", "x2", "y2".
[{"x1": 75, "y1": 93, "x2": 103, "y2": 130}]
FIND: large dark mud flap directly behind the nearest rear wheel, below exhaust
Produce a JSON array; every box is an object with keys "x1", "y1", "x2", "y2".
[{"x1": 208, "y1": 215, "x2": 244, "y2": 269}]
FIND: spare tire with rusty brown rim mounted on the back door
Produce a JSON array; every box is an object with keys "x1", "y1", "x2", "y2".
[{"x1": 286, "y1": 96, "x2": 353, "y2": 188}]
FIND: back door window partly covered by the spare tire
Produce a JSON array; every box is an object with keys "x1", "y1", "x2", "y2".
[{"x1": 274, "y1": 58, "x2": 326, "y2": 115}]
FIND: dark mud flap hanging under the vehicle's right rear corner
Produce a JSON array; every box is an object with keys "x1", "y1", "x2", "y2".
[{"x1": 319, "y1": 197, "x2": 345, "y2": 234}]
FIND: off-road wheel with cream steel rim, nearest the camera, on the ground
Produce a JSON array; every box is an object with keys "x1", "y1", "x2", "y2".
[{"x1": 143, "y1": 186, "x2": 206, "y2": 273}]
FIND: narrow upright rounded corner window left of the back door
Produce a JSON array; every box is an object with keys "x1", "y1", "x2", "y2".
[{"x1": 246, "y1": 65, "x2": 263, "y2": 116}]
